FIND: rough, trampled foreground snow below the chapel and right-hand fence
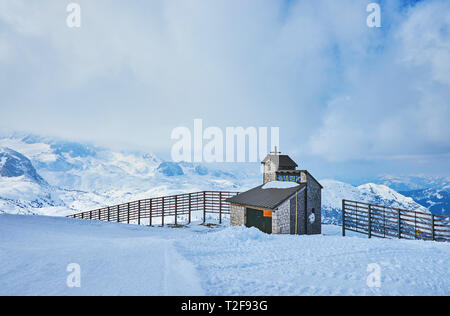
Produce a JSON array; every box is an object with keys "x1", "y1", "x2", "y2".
[{"x1": 176, "y1": 226, "x2": 450, "y2": 295}]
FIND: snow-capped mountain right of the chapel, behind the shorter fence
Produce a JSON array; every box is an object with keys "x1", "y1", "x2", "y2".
[{"x1": 320, "y1": 179, "x2": 428, "y2": 224}]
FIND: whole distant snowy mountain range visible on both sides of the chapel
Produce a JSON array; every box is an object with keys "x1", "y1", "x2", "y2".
[{"x1": 0, "y1": 134, "x2": 449, "y2": 223}]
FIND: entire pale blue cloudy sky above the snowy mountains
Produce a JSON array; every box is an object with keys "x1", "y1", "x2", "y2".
[{"x1": 0, "y1": 0, "x2": 450, "y2": 181}]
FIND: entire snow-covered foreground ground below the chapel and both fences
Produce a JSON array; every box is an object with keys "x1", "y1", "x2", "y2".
[{"x1": 0, "y1": 214, "x2": 450, "y2": 295}]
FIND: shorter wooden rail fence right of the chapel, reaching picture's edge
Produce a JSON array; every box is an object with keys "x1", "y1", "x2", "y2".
[{"x1": 342, "y1": 200, "x2": 450, "y2": 241}]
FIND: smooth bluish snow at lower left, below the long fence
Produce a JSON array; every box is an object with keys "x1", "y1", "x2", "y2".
[{"x1": 0, "y1": 215, "x2": 204, "y2": 295}]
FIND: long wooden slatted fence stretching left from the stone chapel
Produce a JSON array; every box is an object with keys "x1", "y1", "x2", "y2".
[{"x1": 68, "y1": 191, "x2": 238, "y2": 226}]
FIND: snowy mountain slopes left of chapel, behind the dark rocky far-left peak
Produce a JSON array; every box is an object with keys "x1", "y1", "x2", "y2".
[{"x1": 0, "y1": 135, "x2": 260, "y2": 194}]
